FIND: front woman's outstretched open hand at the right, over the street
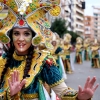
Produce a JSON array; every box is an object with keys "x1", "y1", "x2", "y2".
[{"x1": 78, "y1": 77, "x2": 99, "y2": 100}]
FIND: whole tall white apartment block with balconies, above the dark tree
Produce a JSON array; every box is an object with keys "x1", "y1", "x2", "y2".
[{"x1": 61, "y1": 0, "x2": 85, "y2": 37}]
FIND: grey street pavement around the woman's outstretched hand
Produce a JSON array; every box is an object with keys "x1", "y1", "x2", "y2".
[{"x1": 65, "y1": 52, "x2": 100, "y2": 100}]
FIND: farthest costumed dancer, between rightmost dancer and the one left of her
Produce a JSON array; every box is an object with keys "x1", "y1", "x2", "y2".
[{"x1": 83, "y1": 38, "x2": 91, "y2": 61}]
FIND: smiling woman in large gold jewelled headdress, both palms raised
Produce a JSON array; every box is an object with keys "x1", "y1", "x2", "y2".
[{"x1": 0, "y1": 0, "x2": 98, "y2": 100}]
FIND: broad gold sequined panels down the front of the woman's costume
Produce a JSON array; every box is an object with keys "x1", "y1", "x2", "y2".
[{"x1": 4, "y1": 52, "x2": 47, "y2": 88}]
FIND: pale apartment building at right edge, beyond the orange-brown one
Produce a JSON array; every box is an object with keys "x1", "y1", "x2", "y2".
[{"x1": 93, "y1": 7, "x2": 100, "y2": 41}]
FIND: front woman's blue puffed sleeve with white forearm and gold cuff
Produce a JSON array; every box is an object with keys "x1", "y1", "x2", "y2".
[{"x1": 41, "y1": 55, "x2": 91, "y2": 100}]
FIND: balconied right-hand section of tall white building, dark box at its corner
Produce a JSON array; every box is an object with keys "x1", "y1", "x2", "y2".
[{"x1": 72, "y1": 0, "x2": 85, "y2": 37}]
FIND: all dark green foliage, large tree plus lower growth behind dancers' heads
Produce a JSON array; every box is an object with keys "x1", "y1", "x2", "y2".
[{"x1": 51, "y1": 18, "x2": 79, "y2": 44}]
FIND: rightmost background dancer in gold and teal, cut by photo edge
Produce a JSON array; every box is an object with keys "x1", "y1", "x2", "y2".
[{"x1": 91, "y1": 39, "x2": 100, "y2": 68}]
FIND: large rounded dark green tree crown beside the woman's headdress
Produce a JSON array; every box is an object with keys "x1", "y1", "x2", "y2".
[{"x1": 51, "y1": 18, "x2": 67, "y2": 38}]
